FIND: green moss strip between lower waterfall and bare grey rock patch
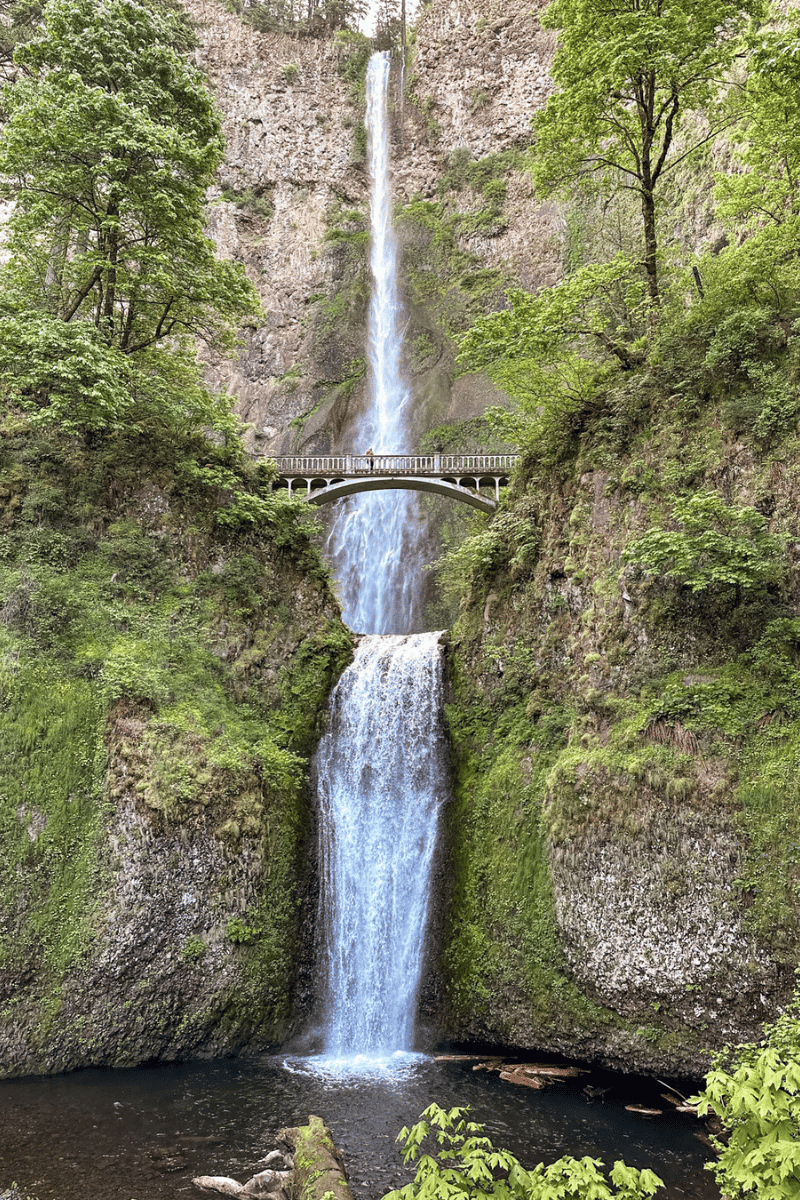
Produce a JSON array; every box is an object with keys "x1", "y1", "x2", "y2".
[{"x1": 444, "y1": 647, "x2": 690, "y2": 1046}]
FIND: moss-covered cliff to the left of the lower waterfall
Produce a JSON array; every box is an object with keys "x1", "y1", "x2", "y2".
[{"x1": 0, "y1": 414, "x2": 350, "y2": 1074}]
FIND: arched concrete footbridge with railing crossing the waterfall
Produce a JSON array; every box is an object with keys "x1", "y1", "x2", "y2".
[{"x1": 272, "y1": 454, "x2": 519, "y2": 512}]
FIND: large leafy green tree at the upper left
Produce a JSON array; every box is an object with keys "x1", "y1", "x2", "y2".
[{"x1": 0, "y1": 0, "x2": 259, "y2": 430}]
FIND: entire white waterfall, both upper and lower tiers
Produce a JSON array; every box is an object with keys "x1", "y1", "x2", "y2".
[{"x1": 314, "y1": 53, "x2": 447, "y2": 1074}]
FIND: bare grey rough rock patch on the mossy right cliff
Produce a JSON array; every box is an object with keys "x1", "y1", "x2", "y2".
[{"x1": 551, "y1": 808, "x2": 783, "y2": 1043}]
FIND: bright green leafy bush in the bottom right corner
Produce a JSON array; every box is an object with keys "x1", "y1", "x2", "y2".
[{"x1": 694, "y1": 994, "x2": 800, "y2": 1200}]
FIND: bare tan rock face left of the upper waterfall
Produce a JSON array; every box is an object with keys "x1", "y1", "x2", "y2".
[{"x1": 186, "y1": 0, "x2": 366, "y2": 450}]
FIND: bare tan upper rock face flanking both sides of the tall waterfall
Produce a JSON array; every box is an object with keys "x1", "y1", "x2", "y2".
[{"x1": 186, "y1": 0, "x2": 563, "y2": 454}]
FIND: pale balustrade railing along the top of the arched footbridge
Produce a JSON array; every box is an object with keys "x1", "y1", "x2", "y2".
[{"x1": 268, "y1": 454, "x2": 519, "y2": 479}]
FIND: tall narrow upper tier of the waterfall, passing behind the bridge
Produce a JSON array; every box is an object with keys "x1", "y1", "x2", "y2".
[{"x1": 326, "y1": 50, "x2": 422, "y2": 634}]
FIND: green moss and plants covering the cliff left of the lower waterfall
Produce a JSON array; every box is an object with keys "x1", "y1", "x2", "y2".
[{"x1": 0, "y1": 420, "x2": 351, "y2": 1057}]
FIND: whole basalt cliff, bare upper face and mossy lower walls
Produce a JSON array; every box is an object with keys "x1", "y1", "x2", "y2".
[{"x1": 0, "y1": 0, "x2": 800, "y2": 1075}]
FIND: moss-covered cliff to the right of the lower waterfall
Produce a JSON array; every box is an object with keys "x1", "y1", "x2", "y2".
[{"x1": 443, "y1": 321, "x2": 800, "y2": 1073}]
